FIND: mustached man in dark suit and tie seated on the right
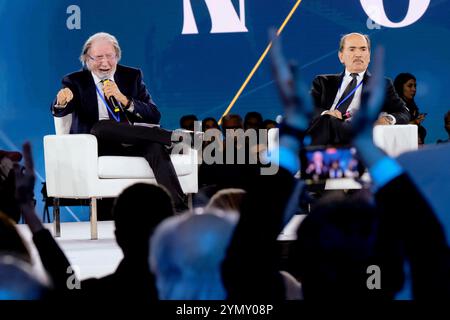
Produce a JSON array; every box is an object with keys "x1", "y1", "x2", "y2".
[{"x1": 308, "y1": 33, "x2": 409, "y2": 145}]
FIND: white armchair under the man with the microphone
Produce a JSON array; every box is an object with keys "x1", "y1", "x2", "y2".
[{"x1": 44, "y1": 115, "x2": 198, "y2": 239}]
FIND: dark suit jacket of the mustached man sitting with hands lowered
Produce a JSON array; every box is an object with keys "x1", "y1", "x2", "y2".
[{"x1": 311, "y1": 71, "x2": 410, "y2": 124}]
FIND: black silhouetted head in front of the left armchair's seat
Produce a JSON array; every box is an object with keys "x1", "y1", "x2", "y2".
[{"x1": 113, "y1": 183, "x2": 174, "y2": 258}]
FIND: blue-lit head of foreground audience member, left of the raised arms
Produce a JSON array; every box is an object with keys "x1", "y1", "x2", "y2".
[{"x1": 149, "y1": 211, "x2": 237, "y2": 300}]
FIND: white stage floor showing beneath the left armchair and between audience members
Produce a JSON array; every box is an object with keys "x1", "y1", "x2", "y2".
[{"x1": 17, "y1": 215, "x2": 305, "y2": 281}]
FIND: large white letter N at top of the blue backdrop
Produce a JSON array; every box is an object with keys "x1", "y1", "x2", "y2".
[{"x1": 181, "y1": 0, "x2": 248, "y2": 34}]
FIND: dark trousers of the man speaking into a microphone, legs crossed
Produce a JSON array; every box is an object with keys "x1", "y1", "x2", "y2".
[{"x1": 91, "y1": 120, "x2": 186, "y2": 210}]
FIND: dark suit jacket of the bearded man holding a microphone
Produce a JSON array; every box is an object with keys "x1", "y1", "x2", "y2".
[{"x1": 51, "y1": 65, "x2": 161, "y2": 133}]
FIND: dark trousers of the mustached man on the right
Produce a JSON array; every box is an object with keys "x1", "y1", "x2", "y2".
[{"x1": 308, "y1": 115, "x2": 351, "y2": 146}]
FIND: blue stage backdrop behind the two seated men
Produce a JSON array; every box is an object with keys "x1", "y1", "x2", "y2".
[{"x1": 0, "y1": 0, "x2": 450, "y2": 221}]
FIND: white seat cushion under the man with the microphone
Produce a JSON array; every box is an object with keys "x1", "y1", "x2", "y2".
[{"x1": 98, "y1": 154, "x2": 193, "y2": 179}]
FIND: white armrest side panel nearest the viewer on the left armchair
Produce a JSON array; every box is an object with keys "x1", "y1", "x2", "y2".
[{"x1": 44, "y1": 134, "x2": 98, "y2": 198}]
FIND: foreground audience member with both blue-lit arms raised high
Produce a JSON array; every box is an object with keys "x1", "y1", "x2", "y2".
[{"x1": 222, "y1": 30, "x2": 450, "y2": 300}]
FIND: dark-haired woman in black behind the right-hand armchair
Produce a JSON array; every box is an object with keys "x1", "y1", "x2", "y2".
[{"x1": 394, "y1": 73, "x2": 427, "y2": 144}]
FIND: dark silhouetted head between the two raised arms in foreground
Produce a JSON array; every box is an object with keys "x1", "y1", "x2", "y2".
[{"x1": 294, "y1": 192, "x2": 403, "y2": 299}]
